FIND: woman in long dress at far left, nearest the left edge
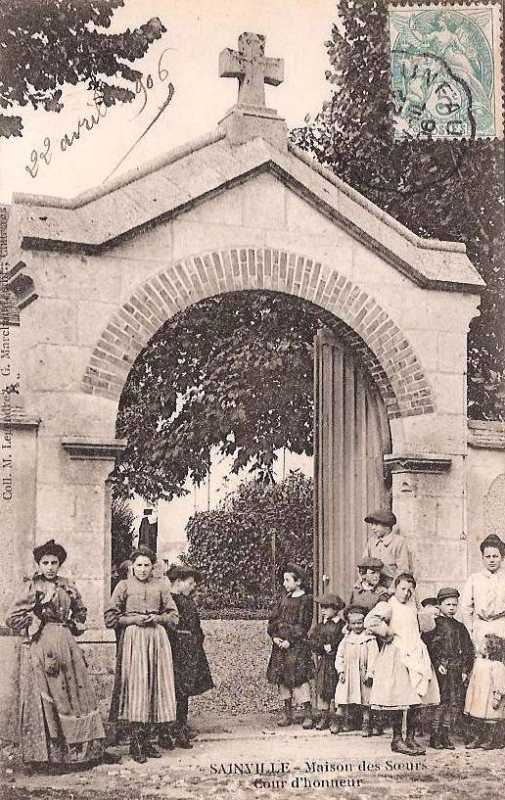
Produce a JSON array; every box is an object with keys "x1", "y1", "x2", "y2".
[{"x1": 6, "y1": 539, "x2": 105, "y2": 764}]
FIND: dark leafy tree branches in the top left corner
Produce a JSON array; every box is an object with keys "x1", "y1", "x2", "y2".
[{"x1": 0, "y1": 0, "x2": 166, "y2": 137}]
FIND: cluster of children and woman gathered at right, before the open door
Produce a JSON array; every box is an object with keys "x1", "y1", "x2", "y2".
[{"x1": 267, "y1": 512, "x2": 505, "y2": 755}]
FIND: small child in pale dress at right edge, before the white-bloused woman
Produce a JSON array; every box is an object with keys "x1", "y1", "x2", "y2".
[{"x1": 465, "y1": 633, "x2": 505, "y2": 750}]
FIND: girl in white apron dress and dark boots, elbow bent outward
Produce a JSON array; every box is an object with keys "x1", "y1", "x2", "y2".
[{"x1": 365, "y1": 573, "x2": 440, "y2": 755}]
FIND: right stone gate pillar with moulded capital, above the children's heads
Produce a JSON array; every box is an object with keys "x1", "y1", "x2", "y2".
[{"x1": 384, "y1": 453, "x2": 467, "y2": 597}]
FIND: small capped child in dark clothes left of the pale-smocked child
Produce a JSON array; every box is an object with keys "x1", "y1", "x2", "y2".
[{"x1": 309, "y1": 594, "x2": 345, "y2": 731}]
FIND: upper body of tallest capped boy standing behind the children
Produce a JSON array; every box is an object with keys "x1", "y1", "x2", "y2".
[{"x1": 363, "y1": 509, "x2": 412, "y2": 579}]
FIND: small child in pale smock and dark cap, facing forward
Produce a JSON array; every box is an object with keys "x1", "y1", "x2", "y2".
[{"x1": 330, "y1": 606, "x2": 379, "y2": 736}]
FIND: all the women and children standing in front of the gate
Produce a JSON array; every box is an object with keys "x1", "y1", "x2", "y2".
[{"x1": 7, "y1": 510, "x2": 505, "y2": 765}]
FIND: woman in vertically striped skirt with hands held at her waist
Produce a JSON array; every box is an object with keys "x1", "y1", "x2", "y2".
[{"x1": 105, "y1": 546, "x2": 179, "y2": 763}]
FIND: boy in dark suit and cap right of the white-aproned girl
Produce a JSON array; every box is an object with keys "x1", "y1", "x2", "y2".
[{"x1": 426, "y1": 587, "x2": 475, "y2": 750}]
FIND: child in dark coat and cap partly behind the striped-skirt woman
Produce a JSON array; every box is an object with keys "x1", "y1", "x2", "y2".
[{"x1": 164, "y1": 565, "x2": 214, "y2": 748}]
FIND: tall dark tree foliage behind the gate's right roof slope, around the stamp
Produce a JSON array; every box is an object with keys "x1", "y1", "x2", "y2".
[{"x1": 291, "y1": 0, "x2": 505, "y2": 419}]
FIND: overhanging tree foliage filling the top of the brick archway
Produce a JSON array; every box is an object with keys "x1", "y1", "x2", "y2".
[{"x1": 114, "y1": 292, "x2": 346, "y2": 501}]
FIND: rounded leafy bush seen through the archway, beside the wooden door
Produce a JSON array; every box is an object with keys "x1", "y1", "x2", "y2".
[{"x1": 186, "y1": 472, "x2": 313, "y2": 609}]
